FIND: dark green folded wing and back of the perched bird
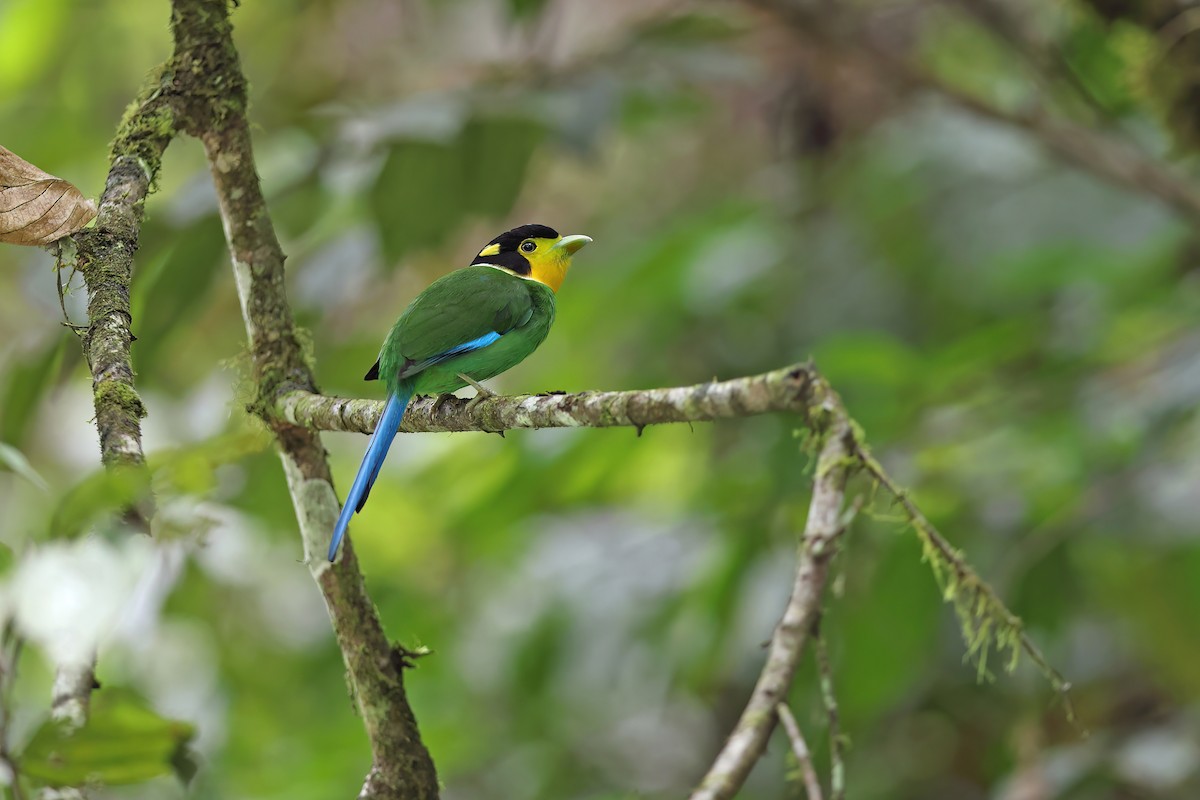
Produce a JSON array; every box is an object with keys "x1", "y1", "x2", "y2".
[{"x1": 366, "y1": 266, "x2": 533, "y2": 380}]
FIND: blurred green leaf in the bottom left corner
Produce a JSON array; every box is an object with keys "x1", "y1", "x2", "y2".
[{"x1": 18, "y1": 688, "x2": 196, "y2": 787}]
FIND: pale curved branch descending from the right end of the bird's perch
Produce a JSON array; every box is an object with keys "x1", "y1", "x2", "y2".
[{"x1": 690, "y1": 412, "x2": 857, "y2": 800}]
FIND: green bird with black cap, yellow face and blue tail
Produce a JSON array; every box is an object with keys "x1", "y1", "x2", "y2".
[{"x1": 329, "y1": 224, "x2": 592, "y2": 561}]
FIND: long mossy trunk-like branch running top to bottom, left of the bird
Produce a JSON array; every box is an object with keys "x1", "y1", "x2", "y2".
[{"x1": 164, "y1": 0, "x2": 438, "y2": 800}]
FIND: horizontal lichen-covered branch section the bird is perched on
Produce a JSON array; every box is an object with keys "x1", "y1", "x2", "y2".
[{"x1": 274, "y1": 363, "x2": 830, "y2": 433}]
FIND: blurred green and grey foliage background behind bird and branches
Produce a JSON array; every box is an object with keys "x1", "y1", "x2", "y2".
[{"x1": 0, "y1": 0, "x2": 1200, "y2": 800}]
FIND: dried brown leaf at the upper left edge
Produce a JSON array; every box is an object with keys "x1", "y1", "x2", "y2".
[{"x1": 0, "y1": 148, "x2": 96, "y2": 246}]
